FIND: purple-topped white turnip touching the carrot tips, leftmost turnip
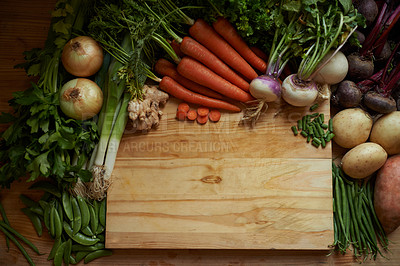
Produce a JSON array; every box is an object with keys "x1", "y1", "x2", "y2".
[{"x1": 250, "y1": 75, "x2": 281, "y2": 102}]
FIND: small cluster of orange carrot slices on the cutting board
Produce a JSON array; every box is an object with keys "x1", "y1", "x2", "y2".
[{"x1": 176, "y1": 102, "x2": 221, "y2": 125}]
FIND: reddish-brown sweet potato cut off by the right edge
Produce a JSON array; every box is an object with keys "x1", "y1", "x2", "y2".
[{"x1": 374, "y1": 155, "x2": 400, "y2": 234}]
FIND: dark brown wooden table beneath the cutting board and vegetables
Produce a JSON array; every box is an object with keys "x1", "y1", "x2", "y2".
[{"x1": 0, "y1": 0, "x2": 400, "y2": 265}]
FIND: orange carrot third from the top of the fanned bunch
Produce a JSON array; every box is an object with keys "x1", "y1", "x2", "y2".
[{"x1": 181, "y1": 37, "x2": 250, "y2": 91}]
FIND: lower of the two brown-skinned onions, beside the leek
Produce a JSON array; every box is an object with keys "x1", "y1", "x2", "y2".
[{"x1": 59, "y1": 78, "x2": 103, "y2": 120}]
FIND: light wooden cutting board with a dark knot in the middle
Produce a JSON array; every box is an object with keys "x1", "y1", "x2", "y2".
[{"x1": 106, "y1": 96, "x2": 333, "y2": 250}]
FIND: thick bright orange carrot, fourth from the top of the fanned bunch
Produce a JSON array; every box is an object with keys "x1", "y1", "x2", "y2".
[{"x1": 178, "y1": 56, "x2": 253, "y2": 102}]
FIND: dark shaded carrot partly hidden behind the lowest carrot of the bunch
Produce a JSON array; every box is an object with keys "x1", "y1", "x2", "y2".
[{"x1": 155, "y1": 58, "x2": 224, "y2": 100}]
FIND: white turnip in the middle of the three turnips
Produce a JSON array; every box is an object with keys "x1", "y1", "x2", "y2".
[{"x1": 282, "y1": 74, "x2": 318, "y2": 107}]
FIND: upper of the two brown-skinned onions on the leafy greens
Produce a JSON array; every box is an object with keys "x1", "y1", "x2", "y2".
[{"x1": 61, "y1": 36, "x2": 104, "y2": 77}]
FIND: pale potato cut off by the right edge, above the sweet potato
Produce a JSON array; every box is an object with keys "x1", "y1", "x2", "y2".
[{"x1": 370, "y1": 111, "x2": 400, "y2": 155}]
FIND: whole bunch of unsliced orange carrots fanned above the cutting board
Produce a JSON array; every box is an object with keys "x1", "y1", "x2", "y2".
[{"x1": 155, "y1": 17, "x2": 267, "y2": 112}]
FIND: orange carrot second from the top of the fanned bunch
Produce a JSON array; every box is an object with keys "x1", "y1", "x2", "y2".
[{"x1": 189, "y1": 19, "x2": 258, "y2": 80}]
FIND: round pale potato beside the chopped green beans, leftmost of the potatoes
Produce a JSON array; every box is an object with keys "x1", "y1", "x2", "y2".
[{"x1": 332, "y1": 108, "x2": 373, "y2": 148}]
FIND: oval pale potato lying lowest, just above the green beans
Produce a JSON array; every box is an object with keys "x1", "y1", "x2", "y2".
[{"x1": 341, "y1": 142, "x2": 387, "y2": 179}]
